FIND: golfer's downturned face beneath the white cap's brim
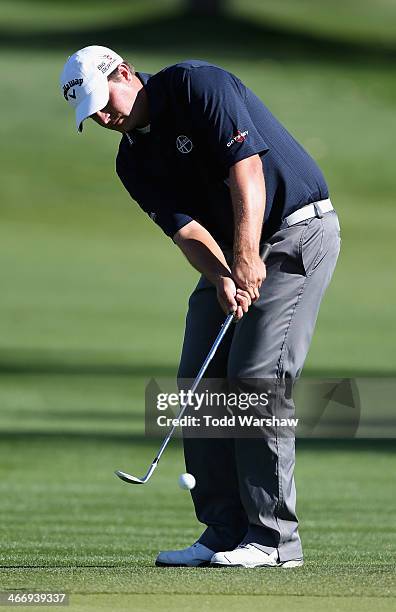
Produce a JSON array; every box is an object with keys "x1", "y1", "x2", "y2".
[{"x1": 91, "y1": 66, "x2": 139, "y2": 132}]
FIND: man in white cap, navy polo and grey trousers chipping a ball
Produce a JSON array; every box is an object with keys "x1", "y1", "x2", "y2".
[{"x1": 61, "y1": 46, "x2": 340, "y2": 568}]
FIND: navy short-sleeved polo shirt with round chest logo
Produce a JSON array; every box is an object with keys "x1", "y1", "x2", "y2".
[{"x1": 116, "y1": 60, "x2": 328, "y2": 247}]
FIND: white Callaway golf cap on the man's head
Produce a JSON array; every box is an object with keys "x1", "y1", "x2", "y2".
[{"x1": 60, "y1": 45, "x2": 124, "y2": 132}]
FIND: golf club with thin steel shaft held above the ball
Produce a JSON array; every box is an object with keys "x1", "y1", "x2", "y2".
[{"x1": 114, "y1": 243, "x2": 271, "y2": 484}]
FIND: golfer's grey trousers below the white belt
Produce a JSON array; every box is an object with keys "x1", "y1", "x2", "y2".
[{"x1": 178, "y1": 211, "x2": 340, "y2": 561}]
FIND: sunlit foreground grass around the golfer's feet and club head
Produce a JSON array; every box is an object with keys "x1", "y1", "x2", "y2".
[{"x1": 0, "y1": 433, "x2": 396, "y2": 610}]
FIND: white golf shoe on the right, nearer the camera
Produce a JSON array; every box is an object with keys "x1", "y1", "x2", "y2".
[{"x1": 210, "y1": 544, "x2": 303, "y2": 568}]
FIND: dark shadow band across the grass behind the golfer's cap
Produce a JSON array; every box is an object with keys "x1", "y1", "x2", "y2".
[{"x1": 0, "y1": 13, "x2": 396, "y2": 67}]
